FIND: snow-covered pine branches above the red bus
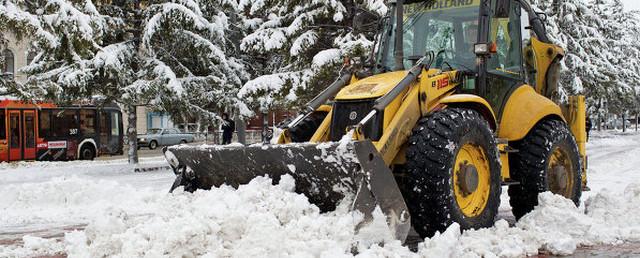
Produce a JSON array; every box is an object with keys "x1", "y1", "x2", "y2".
[{"x1": 0, "y1": 0, "x2": 110, "y2": 101}]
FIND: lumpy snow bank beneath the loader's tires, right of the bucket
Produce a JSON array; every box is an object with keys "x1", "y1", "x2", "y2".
[{"x1": 412, "y1": 184, "x2": 640, "y2": 257}]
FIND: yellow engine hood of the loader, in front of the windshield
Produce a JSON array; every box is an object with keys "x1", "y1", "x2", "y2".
[{"x1": 335, "y1": 71, "x2": 407, "y2": 100}]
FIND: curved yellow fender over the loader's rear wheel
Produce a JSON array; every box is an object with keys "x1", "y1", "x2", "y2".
[{"x1": 498, "y1": 85, "x2": 566, "y2": 141}]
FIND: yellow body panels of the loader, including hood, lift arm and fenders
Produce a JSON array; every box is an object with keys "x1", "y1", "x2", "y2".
[{"x1": 304, "y1": 67, "x2": 586, "y2": 180}]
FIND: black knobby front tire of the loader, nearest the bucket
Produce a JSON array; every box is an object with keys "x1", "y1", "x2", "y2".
[{"x1": 401, "y1": 108, "x2": 502, "y2": 237}]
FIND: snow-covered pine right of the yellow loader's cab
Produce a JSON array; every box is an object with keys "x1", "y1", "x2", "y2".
[{"x1": 532, "y1": 0, "x2": 638, "y2": 123}]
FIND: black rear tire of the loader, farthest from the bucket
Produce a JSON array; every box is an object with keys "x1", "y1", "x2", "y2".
[{"x1": 509, "y1": 120, "x2": 582, "y2": 219}]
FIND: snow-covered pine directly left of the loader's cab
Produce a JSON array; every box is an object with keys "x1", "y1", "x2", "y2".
[{"x1": 239, "y1": 0, "x2": 386, "y2": 115}]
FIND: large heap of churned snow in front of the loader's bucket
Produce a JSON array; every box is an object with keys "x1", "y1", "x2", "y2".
[{"x1": 66, "y1": 176, "x2": 399, "y2": 257}]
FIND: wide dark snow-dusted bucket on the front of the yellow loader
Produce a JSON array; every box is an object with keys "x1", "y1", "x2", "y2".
[{"x1": 164, "y1": 140, "x2": 411, "y2": 242}]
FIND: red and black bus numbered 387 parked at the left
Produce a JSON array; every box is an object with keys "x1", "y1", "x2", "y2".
[{"x1": 0, "y1": 100, "x2": 123, "y2": 162}]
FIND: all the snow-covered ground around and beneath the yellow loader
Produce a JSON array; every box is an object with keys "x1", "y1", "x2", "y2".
[{"x1": 0, "y1": 132, "x2": 640, "y2": 257}]
